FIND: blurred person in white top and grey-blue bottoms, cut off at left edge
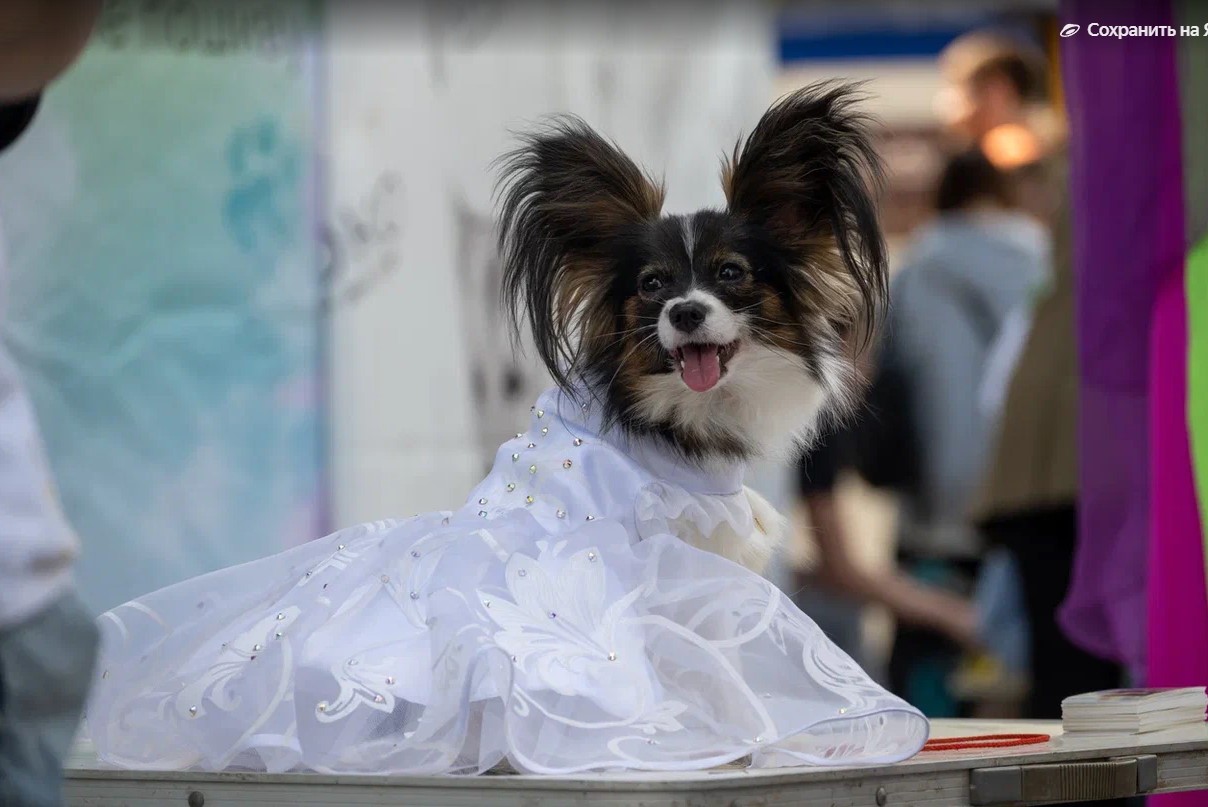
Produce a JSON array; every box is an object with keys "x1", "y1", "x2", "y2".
[{"x1": 0, "y1": 0, "x2": 100, "y2": 807}]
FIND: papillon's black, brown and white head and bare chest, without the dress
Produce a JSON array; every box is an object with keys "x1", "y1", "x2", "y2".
[{"x1": 499, "y1": 82, "x2": 887, "y2": 565}]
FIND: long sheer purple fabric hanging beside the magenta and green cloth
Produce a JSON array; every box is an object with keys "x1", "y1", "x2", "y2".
[{"x1": 1059, "y1": 0, "x2": 1184, "y2": 670}]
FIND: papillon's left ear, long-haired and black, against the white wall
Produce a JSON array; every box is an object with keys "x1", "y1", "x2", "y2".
[{"x1": 498, "y1": 116, "x2": 663, "y2": 387}]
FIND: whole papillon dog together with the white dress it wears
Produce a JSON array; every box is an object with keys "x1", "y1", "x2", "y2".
[{"x1": 88, "y1": 85, "x2": 908, "y2": 774}]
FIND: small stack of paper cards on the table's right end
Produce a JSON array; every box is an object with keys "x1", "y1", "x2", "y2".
[{"x1": 1061, "y1": 686, "x2": 1208, "y2": 735}]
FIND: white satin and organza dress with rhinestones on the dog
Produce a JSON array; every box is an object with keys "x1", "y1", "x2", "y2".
[{"x1": 87, "y1": 391, "x2": 928, "y2": 774}]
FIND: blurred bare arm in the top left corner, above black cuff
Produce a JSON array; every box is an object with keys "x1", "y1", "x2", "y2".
[{"x1": 0, "y1": 0, "x2": 100, "y2": 103}]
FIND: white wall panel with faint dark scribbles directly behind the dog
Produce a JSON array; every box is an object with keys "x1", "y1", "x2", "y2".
[{"x1": 324, "y1": 1, "x2": 774, "y2": 523}]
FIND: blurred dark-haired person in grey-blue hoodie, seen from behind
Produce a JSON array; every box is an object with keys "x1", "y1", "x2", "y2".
[{"x1": 860, "y1": 149, "x2": 1050, "y2": 718}]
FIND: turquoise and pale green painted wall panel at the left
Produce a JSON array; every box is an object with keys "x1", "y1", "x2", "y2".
[{"x1": 0, "y1": 0, "x2": 327, "y2": 610}]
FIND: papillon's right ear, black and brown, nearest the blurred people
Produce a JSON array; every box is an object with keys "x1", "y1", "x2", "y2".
[{"x1": 722, "y1": 82, "x2": 888, "y2": 341}]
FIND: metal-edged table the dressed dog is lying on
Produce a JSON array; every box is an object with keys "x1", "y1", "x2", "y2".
[{"x1": 66, "y1": 720, "x2": 1208, "y2": 807}]
